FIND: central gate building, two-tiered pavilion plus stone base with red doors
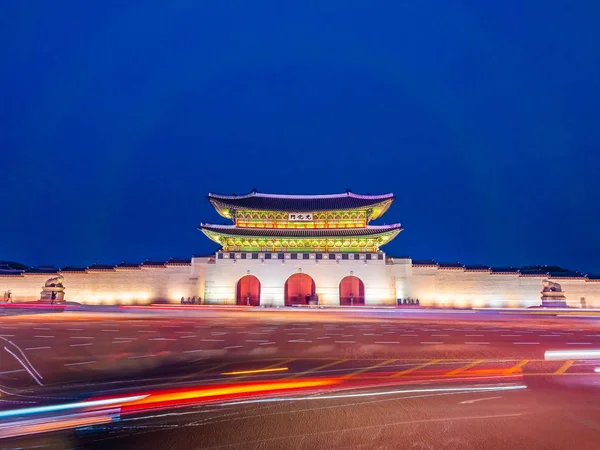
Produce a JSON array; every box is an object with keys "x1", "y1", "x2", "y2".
[{"x1": 199, "y1": 191, "x2": 402, "y2": 306}]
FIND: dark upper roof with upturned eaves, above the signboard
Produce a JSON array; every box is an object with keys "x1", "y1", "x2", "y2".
[{"x1": 208, "y1": 191, "x2": 394, "y2": 219}]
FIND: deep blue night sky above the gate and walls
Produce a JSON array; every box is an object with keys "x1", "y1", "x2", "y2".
[{"x1": 0, "y1": 0, "x2": 600, "y2": 272}]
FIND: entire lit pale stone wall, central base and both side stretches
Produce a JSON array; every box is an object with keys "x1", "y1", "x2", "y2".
[{"x1": 0, "y1": 255, "x2": 600, "y2": 308}]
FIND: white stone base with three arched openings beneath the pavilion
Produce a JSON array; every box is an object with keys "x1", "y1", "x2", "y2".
[{"x1": 205, "y1": 255, "x2": 396, "y2": 306}]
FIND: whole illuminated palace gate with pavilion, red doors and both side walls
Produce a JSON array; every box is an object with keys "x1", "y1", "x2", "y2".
[{"x1": 0, "y1": 188, "x2": 600, "y2": 307}]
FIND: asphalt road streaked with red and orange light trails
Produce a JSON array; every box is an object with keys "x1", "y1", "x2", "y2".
[{"x1": 0, "y1": 310, "x2": 600, "y2": 449}]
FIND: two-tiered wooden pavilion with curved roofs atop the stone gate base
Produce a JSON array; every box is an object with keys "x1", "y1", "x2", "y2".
[{"x1": 200, "y1": 191, "x2": 402, "y2": 253}]
